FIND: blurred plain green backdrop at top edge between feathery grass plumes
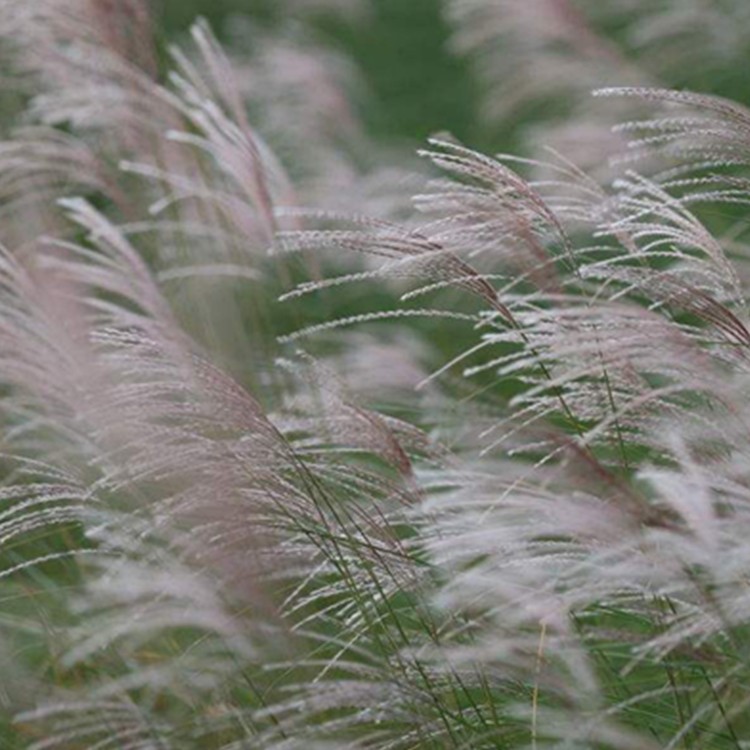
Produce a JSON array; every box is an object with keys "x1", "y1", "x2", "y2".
[{"x1": 160, "y1": 0, "x2": 487, "y2": 145}]
